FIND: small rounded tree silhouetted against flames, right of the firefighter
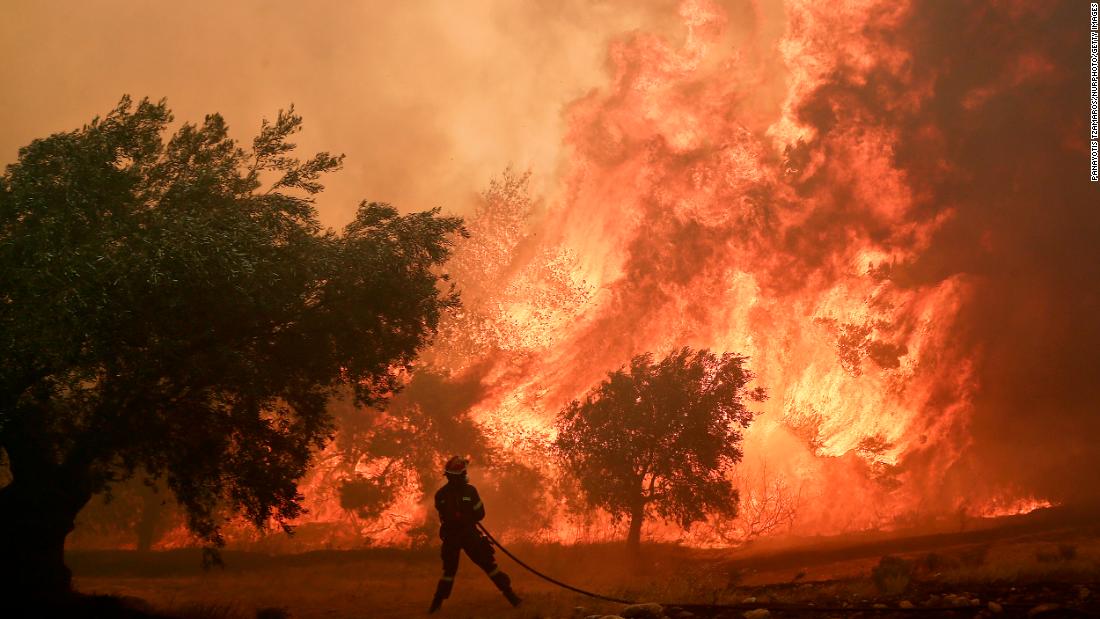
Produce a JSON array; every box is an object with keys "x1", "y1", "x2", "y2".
[{"x1": 554, "y1": 347, "x2": 766, "y2": 550}]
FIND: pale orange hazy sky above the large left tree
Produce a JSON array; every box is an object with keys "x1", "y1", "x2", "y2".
[{"x1": 0, "y1": 0, "x2": 674, "y2": 225}]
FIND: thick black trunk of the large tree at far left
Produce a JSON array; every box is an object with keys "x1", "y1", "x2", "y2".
[{"x1": 0, "y1": 470, "x2": 91, "y2": 600}]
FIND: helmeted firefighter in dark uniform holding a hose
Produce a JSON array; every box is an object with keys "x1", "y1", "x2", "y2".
[{"x1": 428, "y1": 455, "x2": 520, "y2": 612}]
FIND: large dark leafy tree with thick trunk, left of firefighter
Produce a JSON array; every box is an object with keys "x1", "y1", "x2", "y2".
[{"x1": 0, "y1": 98, "x2": 462, "y2": 593}]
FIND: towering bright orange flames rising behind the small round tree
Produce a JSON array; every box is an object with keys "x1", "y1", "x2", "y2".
[{"x1": 294, "y1": 1, "x2": 998, "y2": 541}]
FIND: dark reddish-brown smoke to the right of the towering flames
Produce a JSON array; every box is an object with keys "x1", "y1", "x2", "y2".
[{"x1": 884, "y1": 2, "x2": 1100, "y2": 501}]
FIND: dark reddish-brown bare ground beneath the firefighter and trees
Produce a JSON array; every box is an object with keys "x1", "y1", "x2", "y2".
[{"x1": 58, "y1": 510, "x2": 1100, "y2": 619}]
